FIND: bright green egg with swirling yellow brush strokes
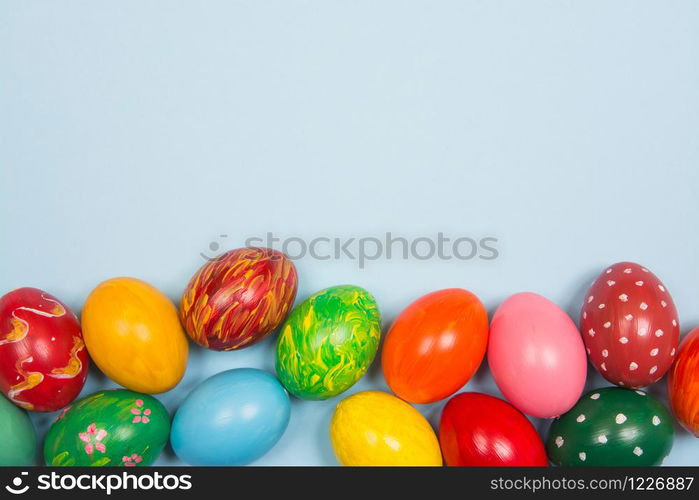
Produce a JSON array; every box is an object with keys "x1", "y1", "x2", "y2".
[{"x1": 276, "y1": 285, "x2": 381, "y2": 399}]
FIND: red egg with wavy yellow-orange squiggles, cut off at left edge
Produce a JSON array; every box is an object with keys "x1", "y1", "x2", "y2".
[{"x1": 0, "y1": 288, "x2": 89, "y2": 411}]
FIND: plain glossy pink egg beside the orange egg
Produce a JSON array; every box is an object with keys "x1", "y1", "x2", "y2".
[{"x1": 488, "y1": 292, "x2": 587, "y2": 418}]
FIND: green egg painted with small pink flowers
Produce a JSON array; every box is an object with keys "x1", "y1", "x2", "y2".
[{"x1": 44, "y1": 389, "x2": 170, "y2": 467}]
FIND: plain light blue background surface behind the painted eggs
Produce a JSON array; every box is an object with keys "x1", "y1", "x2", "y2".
[{"x1": 0, "y1": 0, "x2": 699, "y2": 464}]
